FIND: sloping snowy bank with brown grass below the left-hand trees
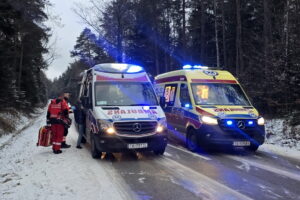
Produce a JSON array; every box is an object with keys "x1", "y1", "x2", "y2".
[{"x1": 0, "y1": 108, "x2": 44, "y2": 149}]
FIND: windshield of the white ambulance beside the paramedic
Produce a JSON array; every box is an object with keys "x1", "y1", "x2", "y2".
[{"x1": 95, "y1": 82, "x2": 158, "y2": 106}]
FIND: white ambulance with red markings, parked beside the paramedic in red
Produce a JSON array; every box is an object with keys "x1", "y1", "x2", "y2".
[{"x1": 79, "y1": 63, "x2": 167, "y2": 158}]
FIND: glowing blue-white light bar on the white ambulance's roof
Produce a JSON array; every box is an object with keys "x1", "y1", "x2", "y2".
[{"x1": 93, "y1": 63, "x2": 144, "y2": 74}]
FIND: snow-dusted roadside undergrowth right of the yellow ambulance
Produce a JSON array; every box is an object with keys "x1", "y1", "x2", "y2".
[{"x1": 265, "y1": 119, "x2": 300, "y2": 151}]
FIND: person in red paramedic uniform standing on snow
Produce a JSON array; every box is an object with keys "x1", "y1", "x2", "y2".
[{"x1": 47, "y1": 94, "x2": 69, "y2": 154}]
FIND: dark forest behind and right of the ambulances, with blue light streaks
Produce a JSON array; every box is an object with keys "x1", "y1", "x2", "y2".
[{"x1": 51, "y1": 0, "x2": 300, "y2": 119}]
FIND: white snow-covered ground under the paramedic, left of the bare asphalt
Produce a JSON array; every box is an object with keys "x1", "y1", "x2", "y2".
[{"x1": 0, "y1": 112, "x2": 135, "y2": 200}]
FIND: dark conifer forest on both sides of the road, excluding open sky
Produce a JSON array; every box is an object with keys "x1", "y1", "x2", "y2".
[{"x1": 0, "y1": 0, "x2": 300, "y2": 119}]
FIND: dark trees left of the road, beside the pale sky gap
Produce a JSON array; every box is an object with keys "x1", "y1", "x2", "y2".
[{"x1": 0, "y1": 0, "x2": 50, "y2": 110}]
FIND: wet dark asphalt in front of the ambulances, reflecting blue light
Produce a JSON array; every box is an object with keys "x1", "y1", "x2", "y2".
[{"x1": 88, "y1": 143, "x2": 300, "y2": 200}]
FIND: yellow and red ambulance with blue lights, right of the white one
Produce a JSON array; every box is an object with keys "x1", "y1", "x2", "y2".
[{"x1": 155, "y1": 65, "x2": 265, "y2": 151}]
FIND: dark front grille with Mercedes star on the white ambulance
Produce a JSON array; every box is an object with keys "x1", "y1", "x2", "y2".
[{"x1": 114, "y1": 121, "x2": 157, "y2": 135}]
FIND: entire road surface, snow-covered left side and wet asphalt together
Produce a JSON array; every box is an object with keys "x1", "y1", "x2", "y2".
[{"x1": 0, "y1": 109, "x2": 300, "y2": 200}]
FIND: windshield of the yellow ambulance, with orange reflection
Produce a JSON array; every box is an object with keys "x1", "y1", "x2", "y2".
[{"x1": 192, "y1": 83, "x2": 250, "y2": 106}]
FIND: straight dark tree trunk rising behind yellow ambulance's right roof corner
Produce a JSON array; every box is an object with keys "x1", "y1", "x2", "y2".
[{"x1": 236, "y1": 0, "x2": 244, "y2": 75}]
